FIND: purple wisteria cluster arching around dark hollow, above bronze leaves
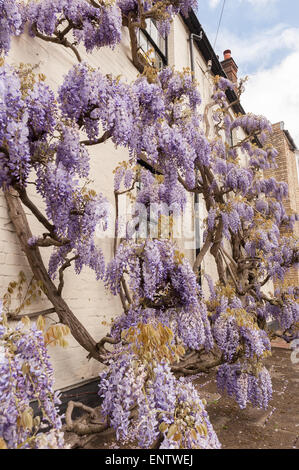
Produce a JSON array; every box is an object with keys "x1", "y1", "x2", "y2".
[{"x1": 106, "y1": 240, "x2": 213, "y2": 350}]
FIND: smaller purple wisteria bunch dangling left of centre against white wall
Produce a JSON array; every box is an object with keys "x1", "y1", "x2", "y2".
[{"x1": 37, "y1": 164, "x2": 108, "y2": 279}]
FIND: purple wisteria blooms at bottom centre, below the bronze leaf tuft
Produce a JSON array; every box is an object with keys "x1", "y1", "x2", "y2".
[{"x1": 99, "y1": 352, "x2": 220, "y2": 449}]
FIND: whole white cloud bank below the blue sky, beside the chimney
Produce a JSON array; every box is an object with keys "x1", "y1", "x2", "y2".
[{"x1": 214, "y1": 24, "x2": 299, "y2": 148}]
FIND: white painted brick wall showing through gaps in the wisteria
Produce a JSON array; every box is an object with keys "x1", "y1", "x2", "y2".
[{"x1": 0, "y1": 18, "x2": 254, "y2": 388}]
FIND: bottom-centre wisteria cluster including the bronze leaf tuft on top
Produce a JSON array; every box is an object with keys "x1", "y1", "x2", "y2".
[{"x1": 99, "y1": 323, "x2": 220, "y2": 449}]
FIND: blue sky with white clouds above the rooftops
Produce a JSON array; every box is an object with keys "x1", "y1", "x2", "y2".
[{"x1": 197, "y1": 0, "x2": 299, "y2": 148}]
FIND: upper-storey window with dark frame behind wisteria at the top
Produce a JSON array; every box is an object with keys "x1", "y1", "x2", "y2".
[{"x1": 138, "y1": 19, "x2": 167, "y2": 70}]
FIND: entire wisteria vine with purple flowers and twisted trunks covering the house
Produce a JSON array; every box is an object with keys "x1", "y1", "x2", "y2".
[{"x1": 0, "y1": 0, "x2": 299, "y2": 449}]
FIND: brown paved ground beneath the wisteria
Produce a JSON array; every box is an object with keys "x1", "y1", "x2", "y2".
[{"x1": 66, "y1": 344, "x2": 299, "y2": 449}]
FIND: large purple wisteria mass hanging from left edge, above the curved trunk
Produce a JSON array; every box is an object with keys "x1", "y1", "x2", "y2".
[{"x1": 0, "y1": 62, "x2": 107, "y2": 279}]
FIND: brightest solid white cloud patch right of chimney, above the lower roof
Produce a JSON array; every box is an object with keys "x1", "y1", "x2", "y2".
[{"x1": 242, "y1": 50, "x2": 299, "y2": 148}]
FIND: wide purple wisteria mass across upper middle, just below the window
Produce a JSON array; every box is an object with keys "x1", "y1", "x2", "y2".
[{"x1": 59, "y1": 64, "x2": 210, "y2": 188}]
